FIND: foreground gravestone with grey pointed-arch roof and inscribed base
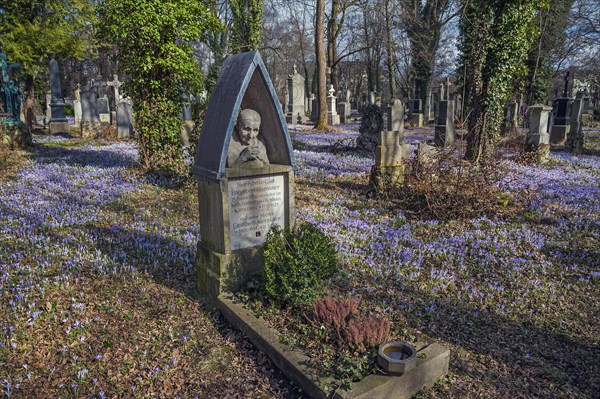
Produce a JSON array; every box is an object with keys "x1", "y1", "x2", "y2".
[{"x1": 193, "y1": 52, "x2": 295, "y2": 300}]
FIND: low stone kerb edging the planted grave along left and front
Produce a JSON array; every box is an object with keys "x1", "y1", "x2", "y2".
[{"x1": 216, "y1": 294, "x2": 450, "y2": 399}]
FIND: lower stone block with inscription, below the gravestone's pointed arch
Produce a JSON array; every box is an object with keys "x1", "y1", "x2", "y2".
[{"x1": 196, "y1": 165, "x2": 294, "y2": 302}]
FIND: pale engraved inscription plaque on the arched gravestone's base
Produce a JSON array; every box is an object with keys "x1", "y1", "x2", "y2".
[{"x1": 228, "y1": 175, "x2": 285, "y2": 250}]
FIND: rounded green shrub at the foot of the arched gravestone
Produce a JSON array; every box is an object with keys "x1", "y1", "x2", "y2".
[{"x1": 264, "y1": 223, "x2": 339, "y2": 307}]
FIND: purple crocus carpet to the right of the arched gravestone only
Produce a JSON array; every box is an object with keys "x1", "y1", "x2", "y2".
[{"x1": 293, "y1": 128, "x2": 600, "y2": 317}]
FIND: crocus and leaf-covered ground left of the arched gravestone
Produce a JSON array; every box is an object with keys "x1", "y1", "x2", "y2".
[{"x1": 0, "y1": 136, "x2": 302, "y2": 398}]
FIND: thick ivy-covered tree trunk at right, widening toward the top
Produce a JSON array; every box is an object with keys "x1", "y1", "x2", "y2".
[{"x1": 460, "y1": 0, "x2": 547, "y2": 163}]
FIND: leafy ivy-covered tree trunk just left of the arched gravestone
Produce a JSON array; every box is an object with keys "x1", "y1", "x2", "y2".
[{"x1": 99, "y1": 0, "x2": 220, "y2": 173}]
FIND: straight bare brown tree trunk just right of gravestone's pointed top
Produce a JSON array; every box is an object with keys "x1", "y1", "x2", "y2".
[{"x1": 315, "y1": 0, "x2": 329, "y2": 130}]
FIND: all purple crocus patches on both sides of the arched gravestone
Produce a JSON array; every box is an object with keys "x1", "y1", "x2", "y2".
[{"x1": 0, "y1": 126, "x2": 600, "y2": 397}]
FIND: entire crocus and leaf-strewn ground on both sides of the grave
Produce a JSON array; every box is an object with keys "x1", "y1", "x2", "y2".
[{"x1": 0, "y1": 126, "x2": 600, "y2": 398}]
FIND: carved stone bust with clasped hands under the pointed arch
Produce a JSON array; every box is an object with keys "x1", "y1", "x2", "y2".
[{"x1": 227, "y1": 109, "x2": 269, "y2": 168}]
